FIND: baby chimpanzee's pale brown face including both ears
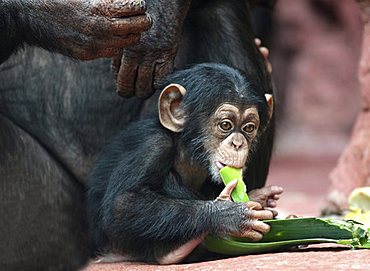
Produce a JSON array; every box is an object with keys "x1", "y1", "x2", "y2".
[{"x1": 158, "y1": 77, "x2": 273, "y2": 185}]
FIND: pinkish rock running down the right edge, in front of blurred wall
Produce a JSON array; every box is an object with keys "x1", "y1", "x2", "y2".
[{"x1": 328, "y1": 1, "x2": 370, "y2": 212}]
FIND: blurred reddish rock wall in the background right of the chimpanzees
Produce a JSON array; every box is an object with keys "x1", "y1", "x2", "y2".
[{"x1": 271, "y1": 0, "x2": 362, "y2": 156}]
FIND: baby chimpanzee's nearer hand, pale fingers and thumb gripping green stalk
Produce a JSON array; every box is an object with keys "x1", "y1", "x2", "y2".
[{"x1": 216, "y1": 181, "x2": 275, "y2": 241}]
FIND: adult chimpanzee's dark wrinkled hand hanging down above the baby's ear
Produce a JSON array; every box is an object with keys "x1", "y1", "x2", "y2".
[{"x1": 112, "y1": 0, "x2": 191, "y2": 98}]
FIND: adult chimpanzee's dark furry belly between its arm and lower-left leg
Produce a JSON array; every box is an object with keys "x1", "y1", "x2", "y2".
[{"x1": 0, "y1": 47, "x2": 143, "y2": 182}]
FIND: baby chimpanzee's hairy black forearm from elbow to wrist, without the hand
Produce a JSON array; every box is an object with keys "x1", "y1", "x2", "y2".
[{"x1": 103, "y1": 184, "x2": 251, "y2": 261}]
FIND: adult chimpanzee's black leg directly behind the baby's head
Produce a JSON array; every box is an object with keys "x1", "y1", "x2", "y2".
[{"x1": 175, "y1": 0, "x2": 274, "y2": 190}]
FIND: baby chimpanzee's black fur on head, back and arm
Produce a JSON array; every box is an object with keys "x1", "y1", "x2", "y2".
[{"x1": 88, "y1": 64, "x2": 268, "y2": 262}]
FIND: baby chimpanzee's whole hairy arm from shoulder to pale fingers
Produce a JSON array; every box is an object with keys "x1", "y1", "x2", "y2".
[{"x1": 88, "y1": 122, "x2": 272, "y2": 262}]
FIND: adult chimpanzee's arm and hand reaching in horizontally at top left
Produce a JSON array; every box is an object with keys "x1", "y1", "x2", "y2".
[{"x1": 0, "y1": 0, "x2": 151, "y2": 63}]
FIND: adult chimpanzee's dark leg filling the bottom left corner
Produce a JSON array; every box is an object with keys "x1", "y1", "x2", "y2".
[{"x1": 0, "y1": 115, "x2": 89, "y2": 270}]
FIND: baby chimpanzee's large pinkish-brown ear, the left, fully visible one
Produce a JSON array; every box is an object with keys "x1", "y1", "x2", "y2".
[{"x1": 158, "y1": 84, "x2": 186, "y2": 133}]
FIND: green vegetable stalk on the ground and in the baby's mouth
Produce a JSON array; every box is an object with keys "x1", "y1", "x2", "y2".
[{"x1": 204, "y1": 167, "x2": 370, "y2": 255}]
